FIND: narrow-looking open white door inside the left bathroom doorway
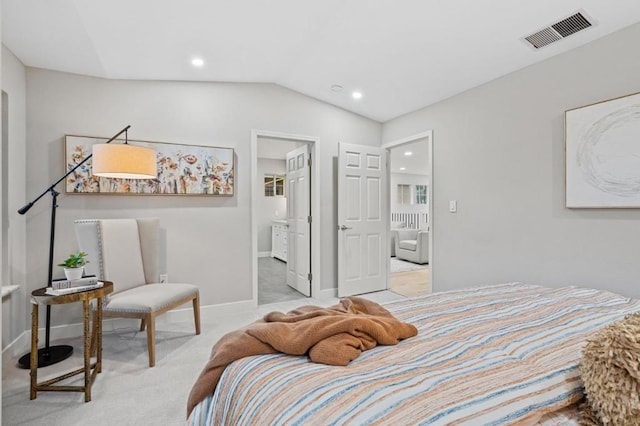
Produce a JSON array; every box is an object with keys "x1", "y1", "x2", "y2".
[{"x1": 286, "y1": 145, "x2": 311, "y2": 296}]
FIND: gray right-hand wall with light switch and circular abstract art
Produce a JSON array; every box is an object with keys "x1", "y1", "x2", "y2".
[{"x1": 383, "y1": 24, "x2": 640, "y2": 297}]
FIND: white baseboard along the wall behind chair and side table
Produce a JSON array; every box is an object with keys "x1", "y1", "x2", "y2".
[{"x1": 2, "y1": 300, "x2": 257, "y2": 365}]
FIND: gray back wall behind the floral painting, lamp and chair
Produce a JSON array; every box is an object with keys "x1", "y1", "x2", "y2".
[{"x1": 26, "y1": 68, "x2": 381, "y2": 325}]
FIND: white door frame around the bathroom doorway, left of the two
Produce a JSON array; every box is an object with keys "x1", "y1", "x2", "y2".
[{"x1": 251, "y1": 129, "x2": 322, "y2": 306}]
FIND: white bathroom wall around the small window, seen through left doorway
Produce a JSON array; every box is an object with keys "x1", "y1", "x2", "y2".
[{"x1": 256, "y1": 158, "x2": 287, "y2": 254}]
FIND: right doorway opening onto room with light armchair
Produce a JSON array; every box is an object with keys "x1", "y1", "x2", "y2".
[{"x1": 385, "y1": 131, "x2": 433, "y2": 297}]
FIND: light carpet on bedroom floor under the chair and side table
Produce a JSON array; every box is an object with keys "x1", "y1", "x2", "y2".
[{"x1": 2, "y1": 291, "x2": 401, "y2": 426}]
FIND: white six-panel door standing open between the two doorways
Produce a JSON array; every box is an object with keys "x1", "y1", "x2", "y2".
[{"x1": 338, "y1": 143, "x2": 389, "y2": 297}]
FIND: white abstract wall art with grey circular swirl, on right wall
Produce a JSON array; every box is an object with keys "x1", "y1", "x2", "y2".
[{"x1": 565, "y1": 93, "x2": 640, "y2": 208}]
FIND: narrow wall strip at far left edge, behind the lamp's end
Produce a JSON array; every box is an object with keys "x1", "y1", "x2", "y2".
[{"x1": 1, "y1": 45, "x2": 31, "y2": 349}]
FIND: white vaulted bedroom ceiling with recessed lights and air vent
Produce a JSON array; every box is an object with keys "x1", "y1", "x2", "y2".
[{"x1": 2, "y1": 0, "x2": 640, "y2": 122}]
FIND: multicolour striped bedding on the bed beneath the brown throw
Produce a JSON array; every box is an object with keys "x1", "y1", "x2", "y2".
[{"x1": 189, "y1": 283, "x2": 640, "y2": 425}]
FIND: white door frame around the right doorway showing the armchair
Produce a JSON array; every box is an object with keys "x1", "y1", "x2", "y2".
[{"x1": 382, "y1": 130, "x2": 435, "y2": 292}]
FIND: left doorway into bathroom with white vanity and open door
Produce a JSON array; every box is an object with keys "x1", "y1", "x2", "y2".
[{"x1": 251, "y1": 130, "x2": 320, "y2": 305}]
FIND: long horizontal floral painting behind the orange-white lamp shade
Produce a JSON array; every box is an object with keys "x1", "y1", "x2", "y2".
[{"x1": 65, "y1": 135, "x2": 234, "y2": 196}]
